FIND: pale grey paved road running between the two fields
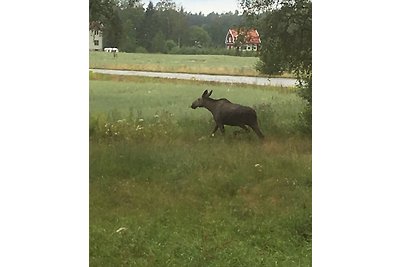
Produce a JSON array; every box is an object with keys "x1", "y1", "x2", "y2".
[{"x1": 89, "y1": 69, "x2": 296, "y2": 87}]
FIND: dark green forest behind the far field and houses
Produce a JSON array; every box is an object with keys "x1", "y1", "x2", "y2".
[{"x1": 89, "y1": 0, "x2": 252, "y2": 54}]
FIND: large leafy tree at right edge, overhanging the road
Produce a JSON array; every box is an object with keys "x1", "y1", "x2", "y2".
[{"x1": 241, "y1": 0, "x2": 312, "y2": 133}]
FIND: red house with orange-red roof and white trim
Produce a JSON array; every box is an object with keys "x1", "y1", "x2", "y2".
[{"x1": 225, "y1": 29, "x2": 261, "y2": 51}]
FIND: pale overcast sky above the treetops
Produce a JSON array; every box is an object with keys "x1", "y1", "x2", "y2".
[{"x1": 142, "y1": 0, "x2": 241, "y2": 15}]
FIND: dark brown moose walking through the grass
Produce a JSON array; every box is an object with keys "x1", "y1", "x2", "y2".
[{"x1": 190, "y1": 90, "x2": 264, "y2": 139}]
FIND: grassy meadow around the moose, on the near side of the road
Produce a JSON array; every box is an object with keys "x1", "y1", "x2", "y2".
[{"x1": 89, "y1": 74, "x2": 312, "y2": 266}]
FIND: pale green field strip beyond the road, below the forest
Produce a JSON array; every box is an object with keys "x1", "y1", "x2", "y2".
[{"x1": 89, "y1": 52, "x2": 268, "y2": 76}]
